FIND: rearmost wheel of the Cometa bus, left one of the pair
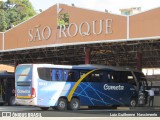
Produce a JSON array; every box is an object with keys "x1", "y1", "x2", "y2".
[{"x1": 57, "y1": 98, "x2": 67, "y2": 111}]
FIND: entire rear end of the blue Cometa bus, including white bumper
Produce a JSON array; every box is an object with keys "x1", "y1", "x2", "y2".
[{"x1": 15, "y1": 64, "x2": 36, "y2": 105}]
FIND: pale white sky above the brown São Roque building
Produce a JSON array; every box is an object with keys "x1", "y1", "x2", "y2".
[{"x1": 29, "y1": 0, "x2": 160, "y2": 14}]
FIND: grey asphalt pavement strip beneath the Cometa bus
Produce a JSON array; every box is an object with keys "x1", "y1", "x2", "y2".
[{"x1": 0, "y1": 106, "x2": 160, "y2": 117}]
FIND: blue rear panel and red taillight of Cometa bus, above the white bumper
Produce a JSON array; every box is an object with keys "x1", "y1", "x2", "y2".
[{"x1": 16, "y1": 65, "x2": 35, "y2": 99}]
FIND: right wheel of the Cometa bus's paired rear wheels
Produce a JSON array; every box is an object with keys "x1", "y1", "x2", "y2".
[{"x1": 68, "y1": 98, "x2": 80, "y2": 110}]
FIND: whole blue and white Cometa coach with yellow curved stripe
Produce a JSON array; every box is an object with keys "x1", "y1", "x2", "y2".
[{"x1": 15, "y1": 64, "x2": 147, "y2": 110}]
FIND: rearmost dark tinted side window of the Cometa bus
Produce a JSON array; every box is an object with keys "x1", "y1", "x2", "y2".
[{"x1": 38, "y1": 68, "x2": 51, "y2": 81}]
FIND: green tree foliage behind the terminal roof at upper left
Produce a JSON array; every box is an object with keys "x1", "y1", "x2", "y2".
[{"x1": 0, "y1": 0, "x2": 36, "y2": 32}]
